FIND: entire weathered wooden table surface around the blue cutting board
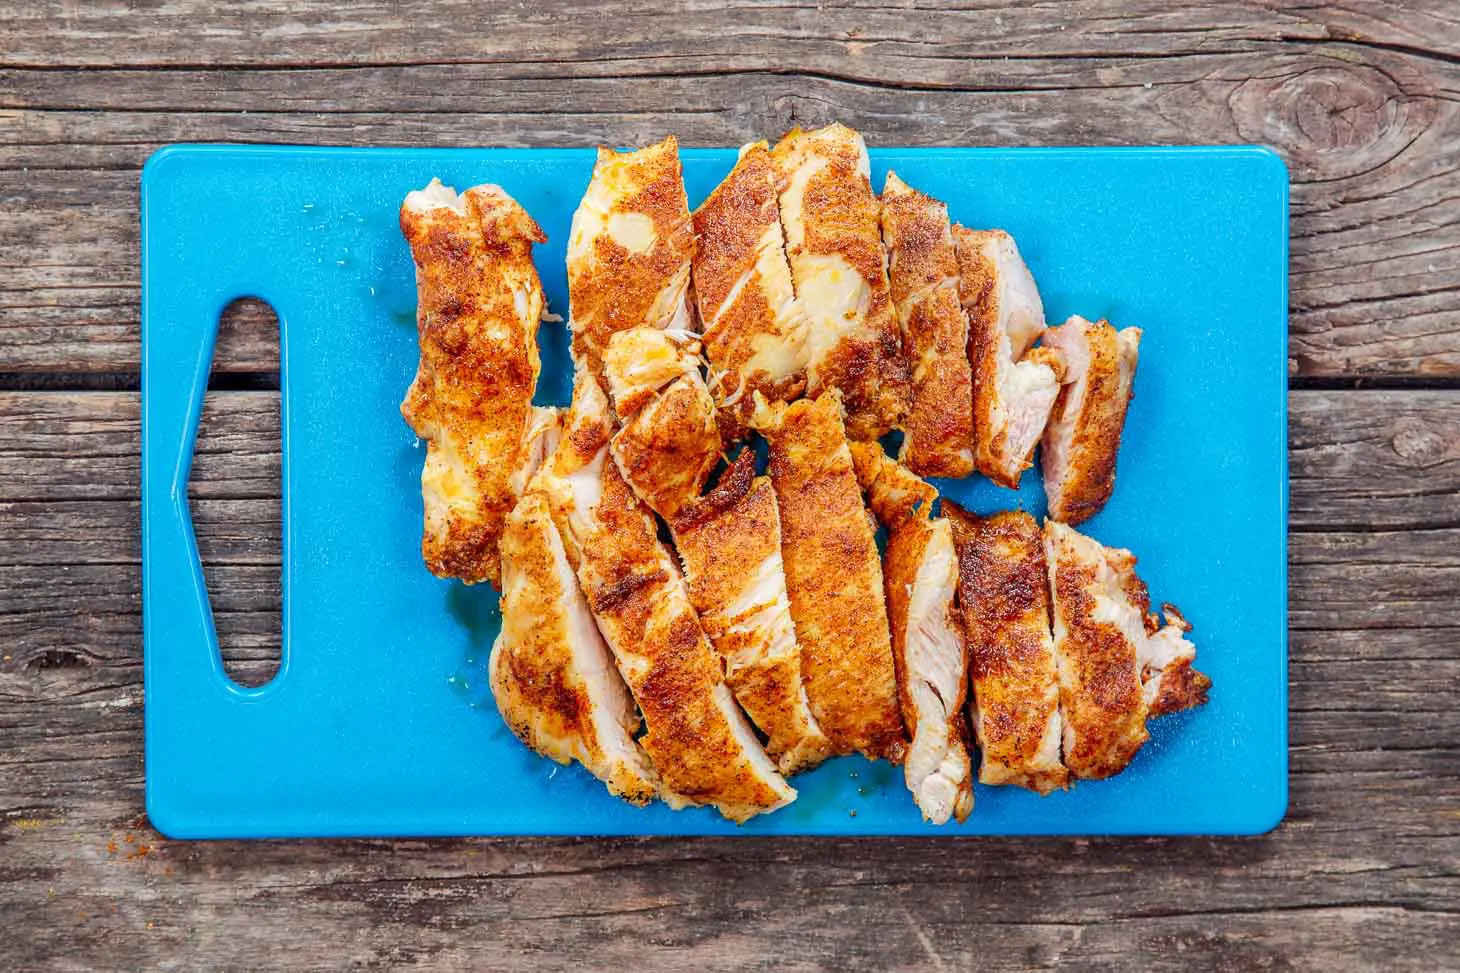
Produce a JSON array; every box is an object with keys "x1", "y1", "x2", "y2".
[{"x1": 0, "y1": 0, "x2": 1460, "y2": 970}]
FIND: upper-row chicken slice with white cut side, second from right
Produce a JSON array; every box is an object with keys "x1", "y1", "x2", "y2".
[{"x1": 953, "y1": 226, "x2": 1060, "y2": 488}]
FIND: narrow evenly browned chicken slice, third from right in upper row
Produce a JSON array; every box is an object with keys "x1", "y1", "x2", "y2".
[{"x1": 882, "y1": 172, "x2": 974, "y2": 478}]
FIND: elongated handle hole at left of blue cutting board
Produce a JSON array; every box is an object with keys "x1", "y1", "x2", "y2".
[{"x1": 188, "y1": 298, "x2": 283, "y2": 688}]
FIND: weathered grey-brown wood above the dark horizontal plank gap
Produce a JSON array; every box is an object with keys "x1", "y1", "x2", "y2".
[{"x1": 0, "y1": 0, "x2": 1460, "y2": 372}]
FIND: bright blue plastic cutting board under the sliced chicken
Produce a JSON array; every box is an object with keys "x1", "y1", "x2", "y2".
[{"x1": 142, "y1": 146, "x2": 1288, "y2": 837}]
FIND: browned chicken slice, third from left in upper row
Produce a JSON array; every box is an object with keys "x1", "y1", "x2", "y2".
[{"x1": 694, "y1": 142, "x2": 809, "y2": 441}]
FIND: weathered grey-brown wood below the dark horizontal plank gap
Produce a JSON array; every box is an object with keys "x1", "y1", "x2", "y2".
[{"x1": 0, "y1": 392, "x2": 1460, "y2": 970}]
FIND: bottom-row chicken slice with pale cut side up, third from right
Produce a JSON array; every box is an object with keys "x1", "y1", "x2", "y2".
[{"x1": 853, "y1": 443, "x2": 974, "y2": 824}]
